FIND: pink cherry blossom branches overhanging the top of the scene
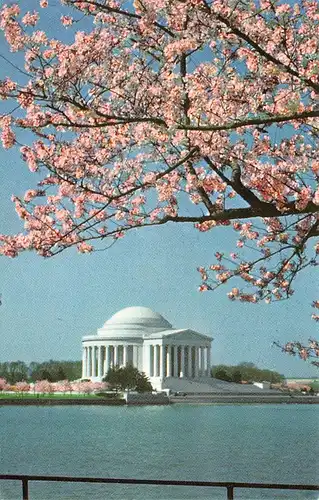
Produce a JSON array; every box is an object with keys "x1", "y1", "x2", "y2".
[{"x1": 0, "y1": 0, "x2": 319, "y2": 324}]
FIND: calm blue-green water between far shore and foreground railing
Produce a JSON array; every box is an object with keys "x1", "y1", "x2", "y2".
[{"x1": 0, "y1": 405, "x2": 319, "y2": 500}]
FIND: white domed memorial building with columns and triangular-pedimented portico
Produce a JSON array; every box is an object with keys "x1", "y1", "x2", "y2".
[{"x1": 82, "y1": 307, "x2": 212, "y2": 390}]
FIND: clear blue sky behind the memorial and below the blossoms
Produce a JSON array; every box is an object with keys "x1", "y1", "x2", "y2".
[{"x1": 0, "y1": 0, "x2": 318, "y2": 377}]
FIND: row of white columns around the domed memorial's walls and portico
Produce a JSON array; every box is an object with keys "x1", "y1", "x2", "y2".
[{"x1": 82, "y1": 344, "x2": 210, "y2": 378}]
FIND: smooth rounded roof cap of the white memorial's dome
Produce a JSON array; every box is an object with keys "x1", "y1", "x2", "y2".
[{"x1": 103, "y1": 307, "x2": 172, "y2": 330}]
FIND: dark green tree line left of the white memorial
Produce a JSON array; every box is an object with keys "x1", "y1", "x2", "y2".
[{"x1": 0, "y1": 359, "x2": 82, "y2": 384}]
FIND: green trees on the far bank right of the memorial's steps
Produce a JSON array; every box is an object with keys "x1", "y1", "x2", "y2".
[{"x1": 211, "y1": 362, "x2": 285, "y2": 384}]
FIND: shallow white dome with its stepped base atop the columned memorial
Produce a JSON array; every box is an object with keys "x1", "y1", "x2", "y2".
[{"x1": 98, "y1": 307, "x2": 172, "y2": 337}]
